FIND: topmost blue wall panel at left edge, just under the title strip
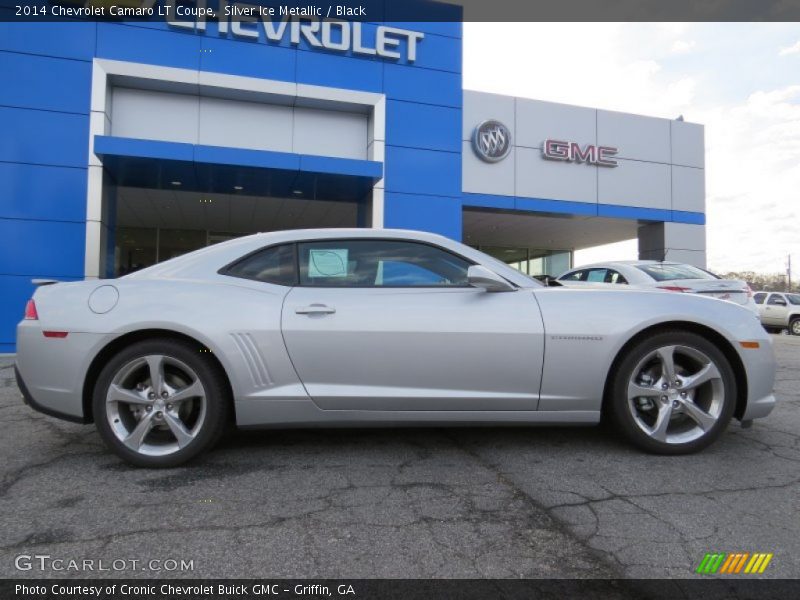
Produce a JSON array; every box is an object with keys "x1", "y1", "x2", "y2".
[{"x1": 0, "y1": 18, "x2": 97, "y2": 61}]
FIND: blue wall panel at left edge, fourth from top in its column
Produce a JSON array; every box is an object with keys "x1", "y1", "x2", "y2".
[{"x1": 0, "y1": 163, "x2": 86, "y2": 222}]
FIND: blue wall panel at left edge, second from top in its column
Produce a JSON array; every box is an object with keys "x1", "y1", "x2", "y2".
[{"x1": 0, "y1": 52, "x2": 92, "y2": 114}]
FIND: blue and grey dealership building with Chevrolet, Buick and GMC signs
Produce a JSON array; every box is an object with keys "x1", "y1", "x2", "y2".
[{"x1": 0, "y1": 3, "x2": 705, "y2": 353}]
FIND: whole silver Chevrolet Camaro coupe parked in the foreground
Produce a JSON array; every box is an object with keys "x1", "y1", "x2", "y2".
[{"x1": 16, "y1": 229, "x2": 775, "y2": 467}]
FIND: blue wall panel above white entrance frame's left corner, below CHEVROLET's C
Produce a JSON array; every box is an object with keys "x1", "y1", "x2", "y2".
[{"x1": 97, "y1": 23, "x2": 202, "y2": 69}]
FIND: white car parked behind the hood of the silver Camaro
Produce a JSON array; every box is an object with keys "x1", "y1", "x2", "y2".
[{"x1": 556, "y1": 260, "x2": 758, "y2": 314}]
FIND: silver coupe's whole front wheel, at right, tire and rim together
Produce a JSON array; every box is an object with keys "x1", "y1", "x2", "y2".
[{"x1": 610, "y1": 331, "x2": 736, "y2": 454}]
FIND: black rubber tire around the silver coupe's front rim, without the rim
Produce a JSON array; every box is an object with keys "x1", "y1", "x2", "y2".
[{"x1": 604, "y1": 330, "x2": 737, "y2": 455}]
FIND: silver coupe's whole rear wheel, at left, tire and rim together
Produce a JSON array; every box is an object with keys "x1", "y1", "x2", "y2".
[{"x1": 93, "y1": 339, "x2": 230, "y2": 467}]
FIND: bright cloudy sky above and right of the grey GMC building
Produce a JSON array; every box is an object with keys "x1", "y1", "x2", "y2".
[{"x1": 464, "y1": 23, "x2": 800, "y2": 272}]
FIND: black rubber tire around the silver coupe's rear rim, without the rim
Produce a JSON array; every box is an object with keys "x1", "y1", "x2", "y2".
[{"x1": 92, "y1": 338, "x2": 231, "y2": 468}]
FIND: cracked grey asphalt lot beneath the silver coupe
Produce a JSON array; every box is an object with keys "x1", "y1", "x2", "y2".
[{"x1": 0, "y1": 336, "x2": 800, "y2": 578}]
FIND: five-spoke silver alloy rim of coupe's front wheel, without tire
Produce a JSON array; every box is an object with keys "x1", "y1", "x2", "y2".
[{"x1": 628, "y1": 345, "x2": 725, "y2": 444}]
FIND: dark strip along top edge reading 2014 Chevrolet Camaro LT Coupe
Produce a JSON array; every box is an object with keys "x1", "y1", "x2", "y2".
[{"x1": 0, "y1": 0, "x2": 800, "y2": 22}]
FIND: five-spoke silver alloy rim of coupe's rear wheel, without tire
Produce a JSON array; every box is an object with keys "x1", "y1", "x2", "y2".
[{"x1": 106, "y1": 354, "x2": 207, "y2": 456}]
